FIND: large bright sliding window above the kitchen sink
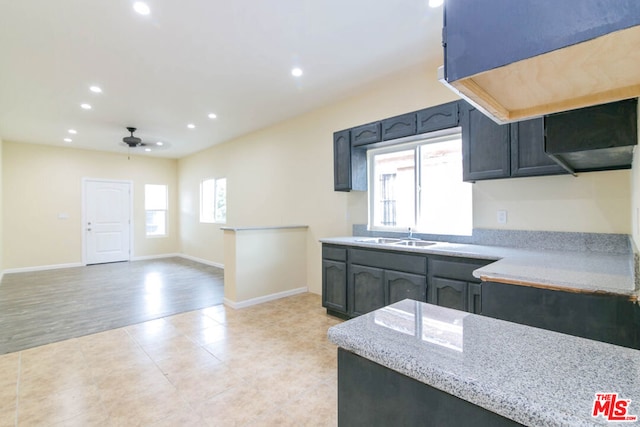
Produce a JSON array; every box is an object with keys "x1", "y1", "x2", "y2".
[{"x1": 367, "y1": 128, "x2": 473, "y2": 237}]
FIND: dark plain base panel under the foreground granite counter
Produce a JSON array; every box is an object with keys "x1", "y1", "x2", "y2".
[{"x1": 338, "y1": 348, "x2": 522, "y2": 427}]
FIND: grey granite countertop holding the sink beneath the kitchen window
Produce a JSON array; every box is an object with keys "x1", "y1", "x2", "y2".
[{"x1": 320, "y1": 237, "x2": 639, "y2": 299}]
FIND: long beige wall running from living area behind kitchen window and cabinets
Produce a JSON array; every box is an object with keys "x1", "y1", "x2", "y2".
[{"x1": 178, "y1": 60, "x2": 637, "y2": 293}]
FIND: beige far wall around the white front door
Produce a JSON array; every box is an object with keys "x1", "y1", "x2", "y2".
[{"x1": 2, "y1": 141, "x2": 179, "y2": 269}]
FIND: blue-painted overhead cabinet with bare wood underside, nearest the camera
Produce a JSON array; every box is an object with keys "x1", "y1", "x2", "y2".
[{"x1": 439, "y1": 0, "x2": 640, "y2": 124}]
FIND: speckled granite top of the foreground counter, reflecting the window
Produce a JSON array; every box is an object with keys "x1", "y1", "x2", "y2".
[{"x1": 328, "y1": 300, "x2": 640, "y2": 426}]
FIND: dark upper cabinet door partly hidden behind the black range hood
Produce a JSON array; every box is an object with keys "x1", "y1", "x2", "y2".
[{"x1": 511, "y1": 117, "x2": 567, "y2": 176}]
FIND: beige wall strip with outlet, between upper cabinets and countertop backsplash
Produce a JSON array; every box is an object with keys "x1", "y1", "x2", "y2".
[{"x1": 473, "y1": 171, "x2": 637, "y2": 234}]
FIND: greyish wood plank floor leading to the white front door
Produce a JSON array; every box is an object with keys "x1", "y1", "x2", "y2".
[{"x1": 0, "y1": 258, "x2": 224, "y2": 354}]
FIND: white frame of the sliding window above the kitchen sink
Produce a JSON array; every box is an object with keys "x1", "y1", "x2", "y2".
[{"x1": 367, "y1": 126, "x2": 473, "y2": 236}]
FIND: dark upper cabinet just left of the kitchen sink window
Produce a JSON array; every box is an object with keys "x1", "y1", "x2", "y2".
[{"x1": 333, "y1": 130, "x2": 367, "y2": 191}]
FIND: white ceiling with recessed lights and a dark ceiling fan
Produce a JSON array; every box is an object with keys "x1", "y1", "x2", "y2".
[{"x1": 0, "y1": 0, "x2": 442, "y2": 158}]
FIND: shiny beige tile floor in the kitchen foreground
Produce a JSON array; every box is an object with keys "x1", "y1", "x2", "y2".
[{"x1": 0, "y1": 294, "x2": 340, "y2": 427}]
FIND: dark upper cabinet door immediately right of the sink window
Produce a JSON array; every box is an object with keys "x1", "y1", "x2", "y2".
[{"x1": 460, "y1": 106, "x2": 511, "y2": 181}]
